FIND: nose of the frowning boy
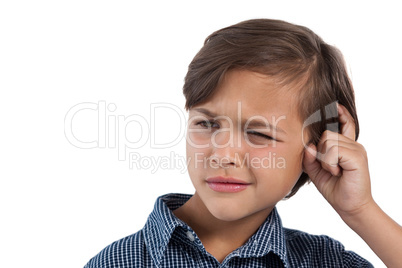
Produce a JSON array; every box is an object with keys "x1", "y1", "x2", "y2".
[{"x1": 210, "y1": 131, "x2": 243, "y2": 168}]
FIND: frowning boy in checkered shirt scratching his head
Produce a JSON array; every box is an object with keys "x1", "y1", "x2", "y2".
[{"x1": 86, "y1": 19, "x2": 402, "y2": 268}]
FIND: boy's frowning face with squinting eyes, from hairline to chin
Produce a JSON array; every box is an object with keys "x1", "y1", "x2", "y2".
[{"x1": 187, "y1": 70, "x2": 308, "y2": 221}]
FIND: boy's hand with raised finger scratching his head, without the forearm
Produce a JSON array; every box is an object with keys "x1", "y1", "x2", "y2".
[{"x1": 303, "y1": 102, "x2": 374, "y2": 217}]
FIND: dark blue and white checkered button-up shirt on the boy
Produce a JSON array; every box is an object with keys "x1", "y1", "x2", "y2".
[{"x1": 84, "y1": 194, "x2": 373, "y2": 268}]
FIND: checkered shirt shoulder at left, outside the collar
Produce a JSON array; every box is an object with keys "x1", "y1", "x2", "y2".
[{"x1": 84, "y1": 230, "x2": 150, "y2": 268}]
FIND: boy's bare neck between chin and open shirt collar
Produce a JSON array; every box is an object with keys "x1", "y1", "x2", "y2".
[{"x1": 173, "y1": 192, "x2": 273, "y2": 262}]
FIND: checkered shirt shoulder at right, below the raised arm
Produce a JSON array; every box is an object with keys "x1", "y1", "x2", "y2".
[{"x1": 284, "y1": 228, "x2": 373, "y2": 267}]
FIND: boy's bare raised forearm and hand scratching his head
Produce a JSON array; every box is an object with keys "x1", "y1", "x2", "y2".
[{"x1": 303, "y1": 105, "x2": 402, "y2": 267}]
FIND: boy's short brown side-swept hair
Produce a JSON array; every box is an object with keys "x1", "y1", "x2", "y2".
[{"x1": 183, "y1": 19, "x2": 359, "y2": 197}]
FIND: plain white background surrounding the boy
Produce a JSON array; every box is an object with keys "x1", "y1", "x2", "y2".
[{"x1": 0, "y1": 0, "x2": 402, "y2": 267}]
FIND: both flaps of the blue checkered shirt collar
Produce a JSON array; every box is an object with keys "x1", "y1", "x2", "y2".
[{"x1": 143, "y1": 194, "x2": 289, "y2": 267}]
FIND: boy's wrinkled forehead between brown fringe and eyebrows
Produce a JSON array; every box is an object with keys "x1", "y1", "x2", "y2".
[{"x1": 190, "y1": 70, "x2": 302, "y2": 134}]
